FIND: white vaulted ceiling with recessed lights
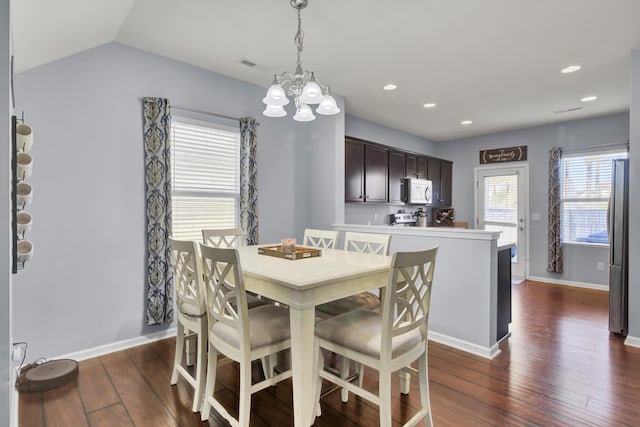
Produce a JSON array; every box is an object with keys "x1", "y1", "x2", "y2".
[{"x1": 11, "y1": 0, "x2": 640, "y2": 141}]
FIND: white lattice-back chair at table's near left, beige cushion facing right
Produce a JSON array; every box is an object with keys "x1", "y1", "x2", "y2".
[{"x1": 200, "y1": 244, "x2": 291, "y2": 427}]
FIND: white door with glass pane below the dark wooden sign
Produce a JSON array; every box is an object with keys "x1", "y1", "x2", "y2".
[{"x1": 476, "y1": 166, "x2": 528, "y2": 277}]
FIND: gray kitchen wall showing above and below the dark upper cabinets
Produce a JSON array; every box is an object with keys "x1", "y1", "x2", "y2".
[{"x1": 342, "y1": 116, "x2": 440, "y2": 224}]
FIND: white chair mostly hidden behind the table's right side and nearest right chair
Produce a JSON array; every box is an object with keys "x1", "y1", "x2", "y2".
[{"x1": 316, "y1": 231, "x2": 391, "y2": 402}]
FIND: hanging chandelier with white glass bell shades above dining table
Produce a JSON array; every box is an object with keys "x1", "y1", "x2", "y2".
[{"x1": 262, "y1": 0, "x2": 340, "y2": 122}]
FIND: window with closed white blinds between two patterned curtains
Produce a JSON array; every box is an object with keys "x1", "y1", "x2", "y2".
[{"x1": 171, "y1": 117, "x2": 240, "y2": 240}]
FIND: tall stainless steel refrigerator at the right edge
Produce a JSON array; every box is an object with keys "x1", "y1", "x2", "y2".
[{"x1": 608, "y1": 159, "x2": 629, "y2": 335}]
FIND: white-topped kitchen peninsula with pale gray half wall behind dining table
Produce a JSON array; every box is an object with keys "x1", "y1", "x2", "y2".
[{"x1": 333, "y1": 224, "x2": 513, "y2": 358}]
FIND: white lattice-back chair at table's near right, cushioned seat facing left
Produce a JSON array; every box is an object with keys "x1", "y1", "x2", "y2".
[{"x1": 315, "y1": 247, "x2": 438, "y2": 427}]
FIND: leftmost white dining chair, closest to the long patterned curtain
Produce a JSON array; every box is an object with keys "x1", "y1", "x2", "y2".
[{"x1": 169, "y1": 238, "x2": 207, "y2": 412}]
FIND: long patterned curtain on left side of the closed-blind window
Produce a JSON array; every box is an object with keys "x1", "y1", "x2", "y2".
[{"x1": 143, "y1": 98, "x2": 174, "y2": 325}]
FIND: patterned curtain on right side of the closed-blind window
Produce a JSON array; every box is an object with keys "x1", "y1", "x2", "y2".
[{"x1": 240, "y1": 117, "x2": 259, "y2": 245}]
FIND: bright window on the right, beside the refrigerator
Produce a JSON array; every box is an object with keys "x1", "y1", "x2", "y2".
[{"x1": 560, "y1": 150, "x2": 627, "y2": 244}]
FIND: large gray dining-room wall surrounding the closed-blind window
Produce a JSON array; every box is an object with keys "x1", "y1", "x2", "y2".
[{"x1": 12, "y1": 42, "x2": 344, "y2": 360}]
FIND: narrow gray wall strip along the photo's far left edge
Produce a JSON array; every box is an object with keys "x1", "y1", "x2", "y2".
[{"x1": 0, "y1": 0, "x2": 13, "y2": 426}]
